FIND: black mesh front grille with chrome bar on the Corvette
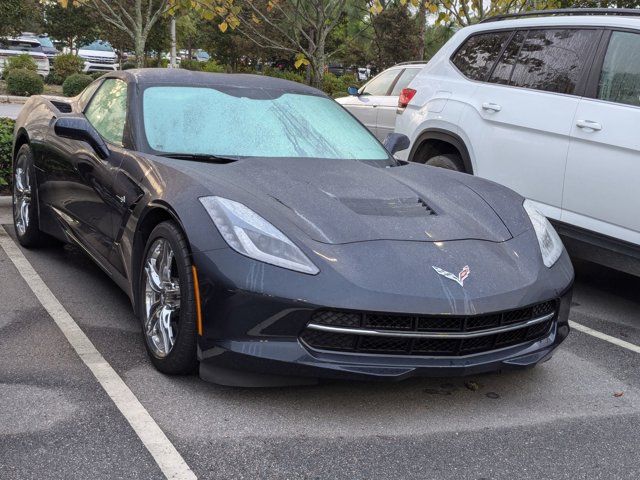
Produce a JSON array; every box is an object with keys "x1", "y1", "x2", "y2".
[{"x1": 300, "y1": 300, "x2": 558, "y2": 356}]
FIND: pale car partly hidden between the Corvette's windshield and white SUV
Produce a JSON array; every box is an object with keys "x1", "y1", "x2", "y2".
[{"x1": 336, "y1": 62, "x2": 426, "y2": 141}]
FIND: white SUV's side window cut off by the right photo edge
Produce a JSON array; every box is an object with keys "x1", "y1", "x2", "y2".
[{"x1": 598, "y1": 32, "x2": 640, "y2": 106}]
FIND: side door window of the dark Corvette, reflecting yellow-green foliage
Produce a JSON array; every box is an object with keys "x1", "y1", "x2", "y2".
[{"x1": 84, "y1": 78, "x2": 127, "y2": 146}]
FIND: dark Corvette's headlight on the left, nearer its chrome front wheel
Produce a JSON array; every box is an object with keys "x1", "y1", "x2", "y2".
[{"x1": 200, "y1": 197, "x2": 320, "y2": 275}]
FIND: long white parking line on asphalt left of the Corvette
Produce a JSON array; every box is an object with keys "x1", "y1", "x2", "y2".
[{"x1": 0, "y1": 226, "x2": 196, "y2": 480}]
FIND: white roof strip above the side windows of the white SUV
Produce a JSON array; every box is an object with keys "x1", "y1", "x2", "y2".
[{"x1": 463, "y1": 15, "x2": 640, "y2": 33}]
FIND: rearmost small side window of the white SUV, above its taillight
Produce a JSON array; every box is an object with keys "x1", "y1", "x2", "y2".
[{"x1": 451, "y1": 31, "x2": 511, "y2": 81}]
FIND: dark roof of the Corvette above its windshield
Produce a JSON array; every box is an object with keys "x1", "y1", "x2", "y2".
[{"x1": 106, "y1": 68, "x2": 326, "y2": 96}]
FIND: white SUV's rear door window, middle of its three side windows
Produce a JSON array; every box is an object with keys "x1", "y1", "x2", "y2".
[{"x1": 509, "y1": 29, "x2": 599, "y2": 94}]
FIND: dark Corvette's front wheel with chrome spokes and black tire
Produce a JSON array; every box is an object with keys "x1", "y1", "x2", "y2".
[{"x1": 138, "y1": 221, "x2": 197, "y2": 375}]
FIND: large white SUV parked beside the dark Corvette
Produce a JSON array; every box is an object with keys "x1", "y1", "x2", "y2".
[{"x1": 395, "y1": 9, "x2": 640, "y2": 274}]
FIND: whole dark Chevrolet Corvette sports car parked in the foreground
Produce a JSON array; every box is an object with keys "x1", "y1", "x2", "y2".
[{"x1": 14, "y1": 69, "x2": 573, "y2": 385}]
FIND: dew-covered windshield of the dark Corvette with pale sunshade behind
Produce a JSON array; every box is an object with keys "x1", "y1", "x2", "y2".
[{"x1": 143, "y1": 86, "x2": 390, "y2": 161}]
